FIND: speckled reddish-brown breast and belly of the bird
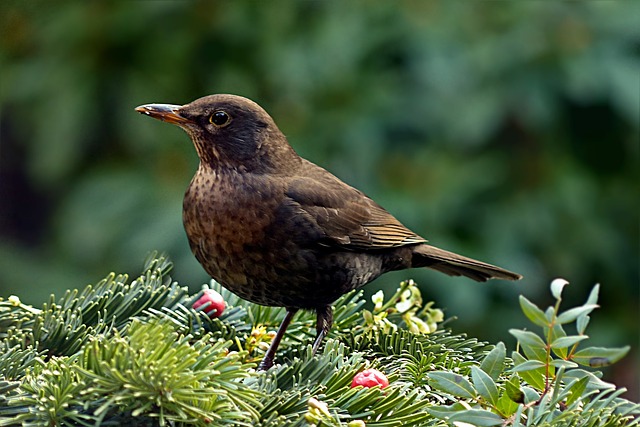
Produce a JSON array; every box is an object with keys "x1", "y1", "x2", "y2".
[{"x1": 183, "y1": 167, "x2": 382, "y2": 308}]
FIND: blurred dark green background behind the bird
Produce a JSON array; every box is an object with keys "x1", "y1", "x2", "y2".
[{"x1": 0, "y1": 0, "x2": 640, "y2": 400}]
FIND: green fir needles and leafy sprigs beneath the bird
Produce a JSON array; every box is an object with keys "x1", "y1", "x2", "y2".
[{"x1": 0, "y1": 256, "x2": 640, "y2": 427}]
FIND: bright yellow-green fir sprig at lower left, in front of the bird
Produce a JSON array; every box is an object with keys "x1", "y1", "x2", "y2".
[{"x1": 77, "y1": 320, "x2": 260, "y2": 425}]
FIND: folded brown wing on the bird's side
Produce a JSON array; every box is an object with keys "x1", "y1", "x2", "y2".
[{"x1": 286, "y1": 175, "x2": 426, "y2": 250}]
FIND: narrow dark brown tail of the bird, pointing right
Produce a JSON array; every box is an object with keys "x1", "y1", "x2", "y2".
[{"x1": 411, "y1": 244, "x2": 522, "y2": 282}]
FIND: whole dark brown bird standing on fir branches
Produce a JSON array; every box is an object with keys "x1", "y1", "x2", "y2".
[{"x1": 136, "y1": 95, "x2": 522, "y2": 369}]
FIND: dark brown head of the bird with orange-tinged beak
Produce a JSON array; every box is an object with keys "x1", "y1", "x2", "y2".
[{"x1": 136, "y1": 95, "x2": 298, "y2": 172}]
